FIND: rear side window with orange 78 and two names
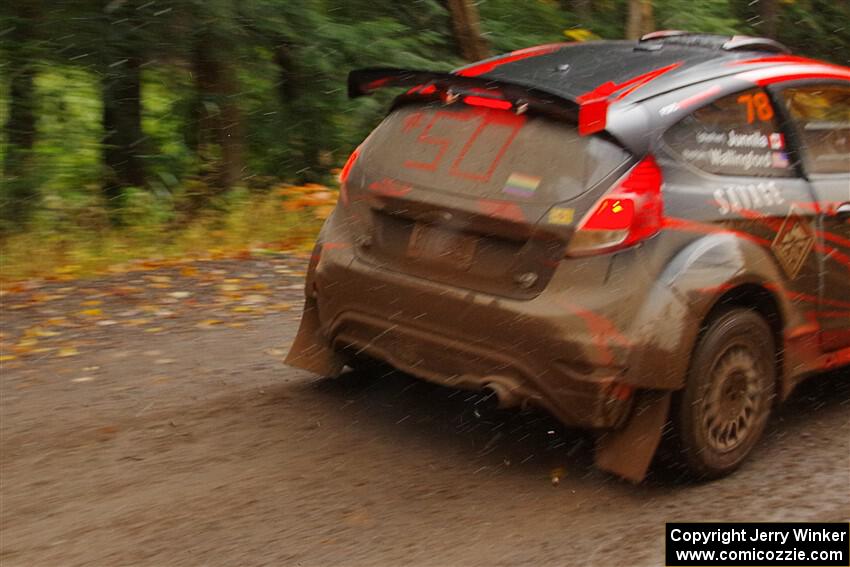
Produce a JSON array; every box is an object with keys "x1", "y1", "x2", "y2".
[{"x1": 664, "y1": 88, "x2": 794, "y2": 177}]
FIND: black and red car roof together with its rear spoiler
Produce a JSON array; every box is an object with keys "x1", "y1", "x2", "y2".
[{"x1": 348, "y1": 31, "x2": 850, "y2": 155}]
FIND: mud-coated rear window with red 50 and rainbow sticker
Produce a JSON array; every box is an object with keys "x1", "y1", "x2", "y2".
[{"x1": 365, "y1": 103, "x2": 628, "y2": 202}]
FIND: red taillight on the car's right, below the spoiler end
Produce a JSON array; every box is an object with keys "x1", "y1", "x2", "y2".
[{"x1": 567, "y1": 155, "x2": 664, "y2": 256}]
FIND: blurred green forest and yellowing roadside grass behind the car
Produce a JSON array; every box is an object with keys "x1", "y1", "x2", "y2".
[{"x1": 0, "y1": 0, "x2": 850, "y2": 280}]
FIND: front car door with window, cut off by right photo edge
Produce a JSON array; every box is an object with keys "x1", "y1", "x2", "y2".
[{"x1": 776, "y1": 81, "x2": 850, "y2": 352}]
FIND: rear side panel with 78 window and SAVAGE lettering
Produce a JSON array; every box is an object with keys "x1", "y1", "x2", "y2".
[{"x1": 661, "y1": 88, "x2": 821, "y2": 311}]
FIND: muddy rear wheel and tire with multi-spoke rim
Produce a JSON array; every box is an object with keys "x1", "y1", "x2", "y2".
[{"x1": 674, "y1": 309, "x2": 776, "y2": 478}]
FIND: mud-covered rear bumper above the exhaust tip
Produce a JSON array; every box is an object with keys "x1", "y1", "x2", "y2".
[{"x1": 298, "y1": 241, "x2": 668, "y2": 428}]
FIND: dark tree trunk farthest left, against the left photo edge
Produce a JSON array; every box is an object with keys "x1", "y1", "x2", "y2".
[{"x1": 0, "y1": 3, "x2": 38, "y2": 228}]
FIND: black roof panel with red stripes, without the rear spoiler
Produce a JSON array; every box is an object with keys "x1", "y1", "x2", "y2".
[{"x1": 455, "y1": 32, "x2": 840, "y2": 101}]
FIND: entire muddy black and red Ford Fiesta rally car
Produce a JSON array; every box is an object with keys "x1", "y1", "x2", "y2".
[{"x1": 287, "y1": 32, "x2": 850, "y2": 480}]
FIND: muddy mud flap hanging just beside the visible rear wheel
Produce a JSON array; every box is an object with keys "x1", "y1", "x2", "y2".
[{"x1": 595, "y1": 392, "x2": 673, "y2": 483}]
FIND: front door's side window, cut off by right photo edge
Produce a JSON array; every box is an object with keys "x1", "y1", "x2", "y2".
[{"x1": 782, "y1": 85, "x2": 850, "y2": 173}]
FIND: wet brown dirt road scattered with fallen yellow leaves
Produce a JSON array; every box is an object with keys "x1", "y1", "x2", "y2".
[{"x1": 0, "y1": 257, "x2": 850, "y2": 567}]
